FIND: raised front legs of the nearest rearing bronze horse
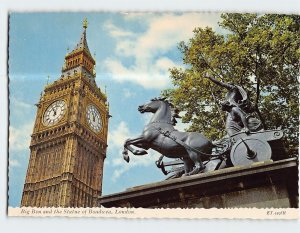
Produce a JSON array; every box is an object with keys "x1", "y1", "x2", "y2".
[{"x1": 123, "y1": 136, "x2": 148, "y2": 162}]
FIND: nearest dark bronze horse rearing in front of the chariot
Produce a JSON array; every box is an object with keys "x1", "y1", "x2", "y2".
[{"x1": 123, "y1": 98, "x2": 213, "y2": 175}]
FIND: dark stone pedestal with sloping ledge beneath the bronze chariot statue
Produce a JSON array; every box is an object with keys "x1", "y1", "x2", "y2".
[{"x1": 99, "y1": 158, "x2": 298, "y2": 208}]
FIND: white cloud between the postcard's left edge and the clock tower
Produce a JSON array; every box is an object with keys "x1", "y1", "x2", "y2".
[{"x1": 9, "y1": 121, "x2": 33, "y2": 151}]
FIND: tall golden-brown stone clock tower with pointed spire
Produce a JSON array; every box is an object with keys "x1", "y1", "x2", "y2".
[{"x1": 21, "y1": 20, "x2": 109, "y2": 207}]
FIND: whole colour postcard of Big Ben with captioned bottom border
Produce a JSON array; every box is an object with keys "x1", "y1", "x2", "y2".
[{"x1": 8, "y1": 11, "x2": 300, "y2": 219}]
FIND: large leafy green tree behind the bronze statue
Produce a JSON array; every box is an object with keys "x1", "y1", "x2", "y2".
[{"x1": 162, "y1": 14, "x2": 300, "y2": 153}]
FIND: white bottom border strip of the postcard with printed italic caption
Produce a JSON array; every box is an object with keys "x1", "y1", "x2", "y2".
[{"x1": 8, "y1": 207, "x2": 300, "y2": 219}]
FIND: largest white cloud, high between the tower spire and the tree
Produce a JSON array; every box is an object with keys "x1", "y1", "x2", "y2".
[{"x1": 104, "y1": 13, "x2": 217, "y2": 89}]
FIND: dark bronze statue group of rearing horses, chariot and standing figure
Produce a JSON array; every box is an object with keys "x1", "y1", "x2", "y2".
[{"x1": 123, "y1": 95, "x2": 283, "y2": 179}]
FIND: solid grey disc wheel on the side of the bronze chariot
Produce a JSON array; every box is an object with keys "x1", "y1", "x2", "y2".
[{"x1": 230, "y1": 138, "x2": 272, "y2": 166}]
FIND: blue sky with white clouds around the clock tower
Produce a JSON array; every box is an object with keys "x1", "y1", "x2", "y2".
[{"x1": 9, "y1": 12, "x2": 219, "y2": 206}]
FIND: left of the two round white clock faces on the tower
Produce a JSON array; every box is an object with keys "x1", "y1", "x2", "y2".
[{"x1": 43, "y1": 100, "x2": 67, "y2": 126}]
